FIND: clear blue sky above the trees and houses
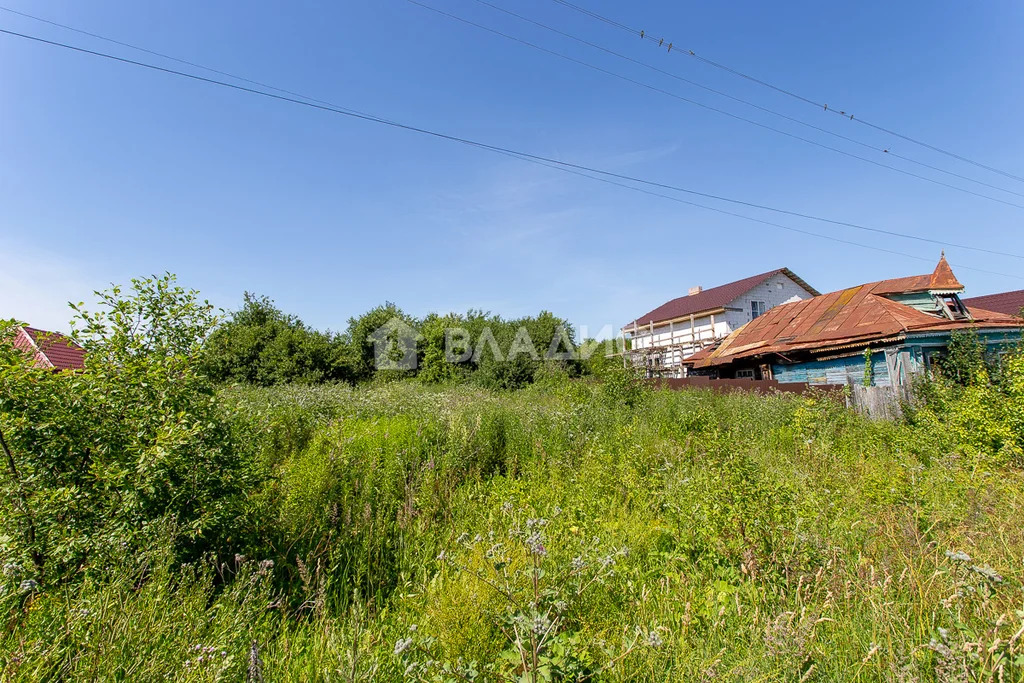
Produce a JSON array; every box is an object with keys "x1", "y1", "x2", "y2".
[{"x1": 0, "y1": 0, "x2": 1024, "y2": 332}]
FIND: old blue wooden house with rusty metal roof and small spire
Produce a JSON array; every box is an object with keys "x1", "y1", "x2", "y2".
[{"x1": 685, "y1": 256, "x2": 1024, "y2": 386}]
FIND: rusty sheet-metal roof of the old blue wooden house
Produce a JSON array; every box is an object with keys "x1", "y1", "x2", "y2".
[{"x1": 685, "y1": 258, "x2": 1021, "y2": 368}]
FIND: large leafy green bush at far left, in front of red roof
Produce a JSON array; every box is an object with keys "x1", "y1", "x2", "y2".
[{"x1": 0, "y1": 274, "x2": 242, "y2": 583}]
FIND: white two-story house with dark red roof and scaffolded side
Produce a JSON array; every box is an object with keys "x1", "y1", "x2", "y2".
[{"x1": 623, "y1": 268, "x2": 818, "y2": 377}]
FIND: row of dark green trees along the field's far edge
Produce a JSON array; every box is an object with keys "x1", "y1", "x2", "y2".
[{"x1": 201, "y1": 292, "x2": 621, "y2": 389}]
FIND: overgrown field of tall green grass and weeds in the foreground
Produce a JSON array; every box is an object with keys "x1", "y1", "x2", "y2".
[{"x1": 0, "y1": 378, "x2": 1024, "y2": 681}]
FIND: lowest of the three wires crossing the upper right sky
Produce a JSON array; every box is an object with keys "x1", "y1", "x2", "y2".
[{"x1": 406, "y1": 0, "x2": 1024, "y2": 209}]
